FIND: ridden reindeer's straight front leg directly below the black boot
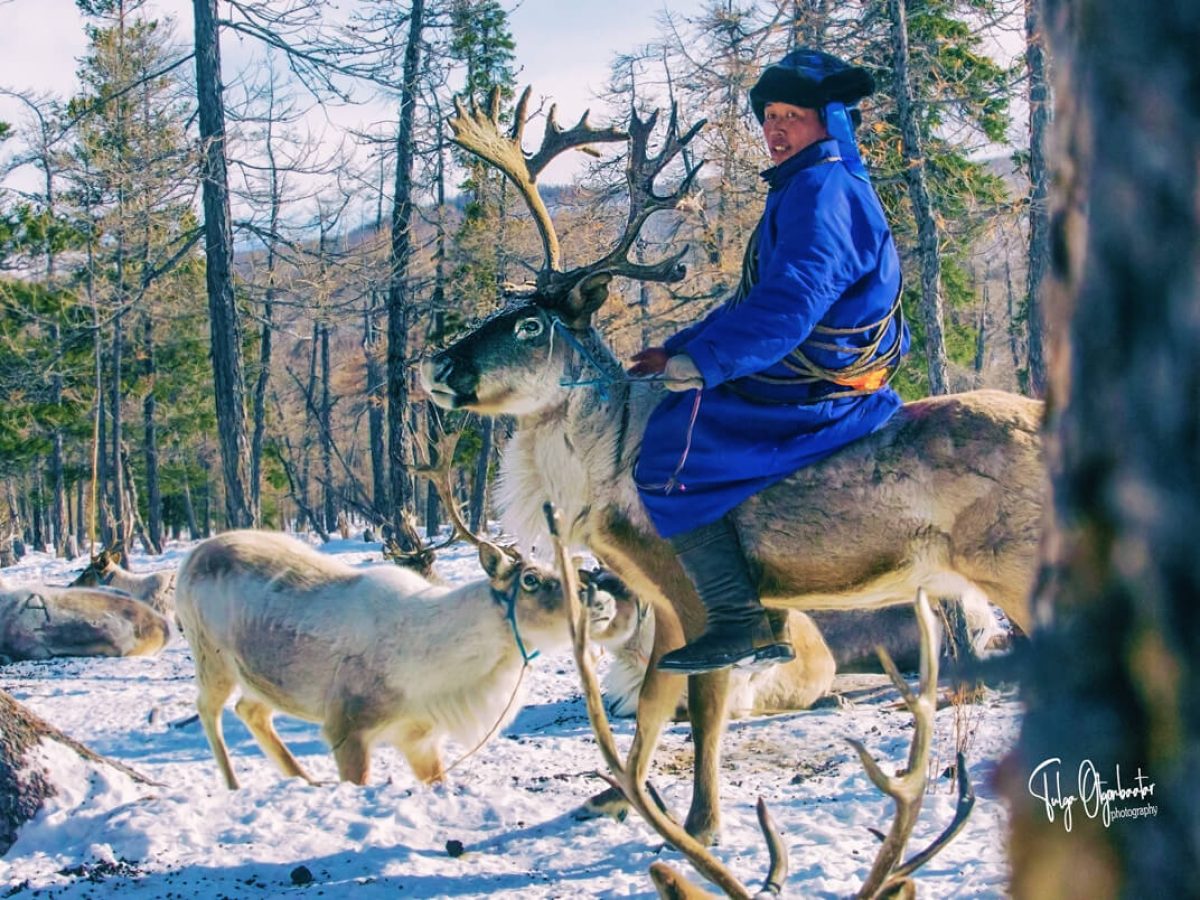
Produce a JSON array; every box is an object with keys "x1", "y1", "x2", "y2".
[{"x1": 684, "y1": 668, "x2": 730, "y2": 845}]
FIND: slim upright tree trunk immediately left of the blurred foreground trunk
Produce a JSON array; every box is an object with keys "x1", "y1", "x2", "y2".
[{"x1": 1025, "y1": 0, "x2": 1051, "y2": 397}]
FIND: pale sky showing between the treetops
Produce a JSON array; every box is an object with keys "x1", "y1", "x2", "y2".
[{"x1": 0, "y1": 0, "x2": 703, "y2": 188}]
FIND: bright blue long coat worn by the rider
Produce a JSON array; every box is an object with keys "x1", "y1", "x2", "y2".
[{"x1": 634, "y1": 140, "x2": 908, "y2": 538}]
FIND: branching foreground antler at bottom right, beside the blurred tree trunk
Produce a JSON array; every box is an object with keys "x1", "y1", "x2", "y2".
[{"x1": 850, "y1": 590, "x2": 974, "y2": 900}]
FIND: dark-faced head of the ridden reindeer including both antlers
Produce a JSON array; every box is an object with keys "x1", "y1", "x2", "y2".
[{"x1": 421, "y1": 88, "x2": 704, "y2": 415}]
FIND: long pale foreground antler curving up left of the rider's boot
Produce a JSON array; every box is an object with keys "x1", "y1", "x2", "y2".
[{"x1": 545, "y1": 503, "x2": 787, "y2": 900}]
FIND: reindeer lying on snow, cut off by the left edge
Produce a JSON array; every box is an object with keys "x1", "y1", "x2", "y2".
[{"x1": 0, "y1": 580, "x2": 170, "y2": 661}]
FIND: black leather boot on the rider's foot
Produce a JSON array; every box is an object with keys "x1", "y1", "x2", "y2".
[{"x1": 658, "y1": 518, "x2": 796, "y2": 674}]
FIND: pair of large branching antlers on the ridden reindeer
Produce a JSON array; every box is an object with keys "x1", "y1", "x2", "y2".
[{"x1": 450, "y1": 88, "x2": 704, "y2": 304}]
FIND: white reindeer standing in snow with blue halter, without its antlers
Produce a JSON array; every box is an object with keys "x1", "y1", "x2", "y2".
[{"x1": 175, "y1": 532, "x2": 570, "y2": 788}]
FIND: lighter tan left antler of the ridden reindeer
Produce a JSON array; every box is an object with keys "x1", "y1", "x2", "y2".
[{"x1": 450, "y1": 88, "x2": 629, "y2": 280}]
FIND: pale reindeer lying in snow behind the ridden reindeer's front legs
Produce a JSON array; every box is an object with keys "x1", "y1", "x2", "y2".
[{"x1": 581, "y1": 569, "x2": 835, "y2": 719}]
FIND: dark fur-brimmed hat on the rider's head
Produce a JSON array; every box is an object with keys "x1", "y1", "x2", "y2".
[{"x1": 750, "y1": 47, "x2": 875, "y2": 124}]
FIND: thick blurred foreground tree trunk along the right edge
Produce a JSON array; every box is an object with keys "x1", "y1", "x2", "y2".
[{"x1": 1004, "y1": 0, "x2": 1200, "y2": 900}]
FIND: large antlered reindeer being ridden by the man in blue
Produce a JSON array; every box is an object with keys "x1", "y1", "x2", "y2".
[{"x1": 422, "y1": 84, "x2": 1046, "y2": 840}]
